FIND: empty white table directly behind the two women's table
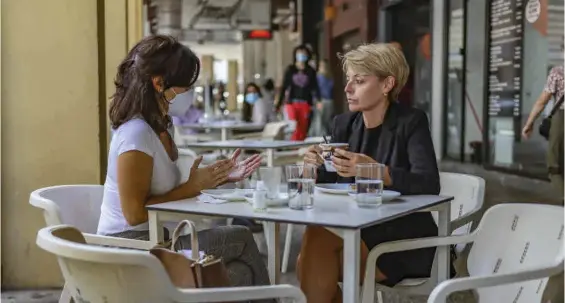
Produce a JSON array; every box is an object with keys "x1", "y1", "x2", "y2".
[{"x1": 179, "y1": 140, "x2": 322, "y2": 167}]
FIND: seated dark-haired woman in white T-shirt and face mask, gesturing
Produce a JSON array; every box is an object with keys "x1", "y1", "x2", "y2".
[{"x1": 98, "y1": 35, "x2": 269, "y2": 294}]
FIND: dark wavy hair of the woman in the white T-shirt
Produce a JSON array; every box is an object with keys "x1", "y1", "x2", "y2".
[{"x1": 110, "y1": 35, "x2": 200, "y2": 133}]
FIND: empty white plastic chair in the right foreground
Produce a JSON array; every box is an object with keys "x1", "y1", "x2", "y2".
[{"x1": 362, "y1": 203, "x2": 564, "y2": 303}]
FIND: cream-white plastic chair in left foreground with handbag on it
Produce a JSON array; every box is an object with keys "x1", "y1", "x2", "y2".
[{"x1": 37, "y1": 225, "x2": 306, "y2": 303}]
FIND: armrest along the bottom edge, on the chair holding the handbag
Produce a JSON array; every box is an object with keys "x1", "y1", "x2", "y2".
[{"x1": 172, "y1": 285, "x2": 306, "y2": 303}]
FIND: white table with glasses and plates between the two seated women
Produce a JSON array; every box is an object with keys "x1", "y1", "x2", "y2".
[{"x1": 147, "y1": 192, "x2": 453, "y2": 303}]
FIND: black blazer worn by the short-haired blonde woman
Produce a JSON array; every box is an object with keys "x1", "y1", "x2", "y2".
[{"x1": 317, "y1": 102, "x2": 440, "y2": 195}]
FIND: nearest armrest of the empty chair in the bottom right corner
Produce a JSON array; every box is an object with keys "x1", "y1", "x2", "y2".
[{"x1": 428, "y1": 259, "x2": 563, "y2": 303}]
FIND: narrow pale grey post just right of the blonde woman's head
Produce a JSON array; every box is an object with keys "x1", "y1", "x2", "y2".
[{"x1": 430, "y1": 0, "x2": 447, "y2": 160}]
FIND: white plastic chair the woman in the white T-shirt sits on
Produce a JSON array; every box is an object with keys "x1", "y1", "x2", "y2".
[{"x1": 29, "y1": 184, "x2": 151, "y2": 249}]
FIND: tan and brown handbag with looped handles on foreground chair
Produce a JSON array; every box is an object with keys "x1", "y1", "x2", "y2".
[{"x1": 150, "y1": 220, "x2": 231, "y2": 288}]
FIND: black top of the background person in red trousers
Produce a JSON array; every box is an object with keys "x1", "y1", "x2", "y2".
[{"x1": 277, "y1": 64, "x2": 320, "y2": 110}]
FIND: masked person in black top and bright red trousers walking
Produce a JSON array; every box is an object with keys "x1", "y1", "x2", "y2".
[{"x1": 276, "y1": 45, "x2": 320, "y2": 141}]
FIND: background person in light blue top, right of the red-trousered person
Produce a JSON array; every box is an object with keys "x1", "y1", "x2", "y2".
[{"x1": 318, "y1": 59, "x2": 334, "y2": 135}]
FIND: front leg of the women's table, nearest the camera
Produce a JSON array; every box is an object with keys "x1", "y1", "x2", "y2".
[{"x1": 343, "y1": 230, "x2": 361, "y2": 303}]
